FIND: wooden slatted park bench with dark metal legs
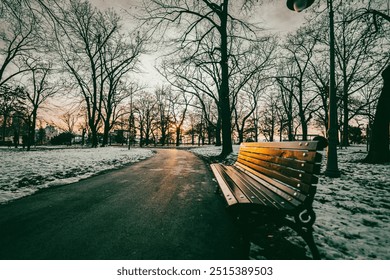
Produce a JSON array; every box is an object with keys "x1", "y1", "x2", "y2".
[{"x1": 211, "y1": 141, "x2": 322, "y2": 259}]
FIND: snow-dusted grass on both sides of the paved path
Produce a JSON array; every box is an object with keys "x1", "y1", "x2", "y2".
[{"x1": 0, "y1": 146, "x2": 390, "y2": 260}]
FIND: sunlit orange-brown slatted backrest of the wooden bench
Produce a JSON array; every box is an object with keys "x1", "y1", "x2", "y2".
[{"x1": 235, "y1": 141, "x2": 322, "y2": 204}]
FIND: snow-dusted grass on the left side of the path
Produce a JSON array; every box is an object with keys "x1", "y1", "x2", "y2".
[{"x1": 0, "y1": 147, "x2": 153, "y2": 204}]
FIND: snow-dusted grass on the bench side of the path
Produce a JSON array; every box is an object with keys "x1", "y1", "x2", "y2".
[{"x1": 193, "y1": 146, "x2": 390, "y2": 260}]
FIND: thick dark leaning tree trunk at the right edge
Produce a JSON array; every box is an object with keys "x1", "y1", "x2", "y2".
[{"x1": 364, "y1": 65, "x2": 390, "y2": 163}]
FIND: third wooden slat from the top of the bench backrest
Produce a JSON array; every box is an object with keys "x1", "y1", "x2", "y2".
[{"x1": 240, "y1": 149, "x2": 321, "y2": 174}]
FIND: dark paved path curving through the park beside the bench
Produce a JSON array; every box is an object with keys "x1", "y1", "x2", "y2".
[{"x1": 0, "y1": 150, "x2": 237, "y2": 259}]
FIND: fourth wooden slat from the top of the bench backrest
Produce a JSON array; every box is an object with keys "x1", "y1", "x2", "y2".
[{"x1": 238, "y1": 155, "x2": 318, "y2": 184}]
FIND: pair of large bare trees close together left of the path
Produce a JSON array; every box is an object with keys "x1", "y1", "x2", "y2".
[{"x1": 51, "y1": 0, "x2": 144, "y2": 147}]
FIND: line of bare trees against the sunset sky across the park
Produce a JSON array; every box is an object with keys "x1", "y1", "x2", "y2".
[{"x1": 0, "y1": 0, "x2": 390, "y2": 161}]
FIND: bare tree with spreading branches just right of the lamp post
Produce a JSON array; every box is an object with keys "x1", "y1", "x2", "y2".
[{"x1": 335, "y1": 3, "x2": 390, "y2": 146}]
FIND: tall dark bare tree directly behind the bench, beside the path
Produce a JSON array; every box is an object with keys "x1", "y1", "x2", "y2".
[{"x1": 140, "y1": 0, "x2": 262, "y2": 157}]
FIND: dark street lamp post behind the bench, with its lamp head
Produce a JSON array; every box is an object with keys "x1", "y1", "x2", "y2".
[{"x1": 286, "y1": 0, "x2": 340, "y2": 178}]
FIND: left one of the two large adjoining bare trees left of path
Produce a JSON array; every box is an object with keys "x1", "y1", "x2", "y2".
[{"x1": 55, "y1": 0, "x2": 119, "y2": 147}]
